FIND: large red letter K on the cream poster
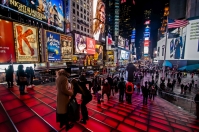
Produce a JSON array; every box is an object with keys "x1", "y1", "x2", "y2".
[{"x1": 16, "y1": 25, "x2": 34, "y2": 56}]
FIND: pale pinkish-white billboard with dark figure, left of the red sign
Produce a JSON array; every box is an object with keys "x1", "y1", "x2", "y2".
[{"x1": 75, "y1": 34, "x2": 87, "y2": 54}]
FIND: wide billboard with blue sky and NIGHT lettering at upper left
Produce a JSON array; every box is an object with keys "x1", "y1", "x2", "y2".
[{"x1": 6, "y1": 0, "x2": 64, "y2": 31}]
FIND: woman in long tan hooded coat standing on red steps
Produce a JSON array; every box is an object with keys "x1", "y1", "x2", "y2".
[{"x1": 56, "y1": 69, "x2": 73, "y2": 130}]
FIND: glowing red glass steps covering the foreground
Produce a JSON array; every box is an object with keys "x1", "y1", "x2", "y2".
[{"x1": 0, "y1": 83, "x2": 199, "y2": 132}]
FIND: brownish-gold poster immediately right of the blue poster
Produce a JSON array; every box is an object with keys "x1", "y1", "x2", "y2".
[{"x1": 61, "y1": 35, "x2": 73, "y2": 61}]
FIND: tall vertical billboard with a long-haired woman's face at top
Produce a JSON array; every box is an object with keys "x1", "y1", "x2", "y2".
[{"x1": 91, "y1": 0, "x2": 106, "y2": 42}]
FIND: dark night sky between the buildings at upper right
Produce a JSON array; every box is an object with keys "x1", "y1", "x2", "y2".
[{"x1": 135, "y1": 0, "x2": 168, "y2": 56}]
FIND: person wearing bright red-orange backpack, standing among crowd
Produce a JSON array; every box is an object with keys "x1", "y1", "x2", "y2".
[{"x1": 126, "y1": 81, "x2": 134, "y2": 103}]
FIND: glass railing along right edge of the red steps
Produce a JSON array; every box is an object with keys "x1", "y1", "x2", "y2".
[{"x1": 158, "y1": 89, "x2": 196, "y2": 115}]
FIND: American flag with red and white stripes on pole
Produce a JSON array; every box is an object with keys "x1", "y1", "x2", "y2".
[{"x1": 168, "y1": 19, "x2": 189, "y2": 29}]
